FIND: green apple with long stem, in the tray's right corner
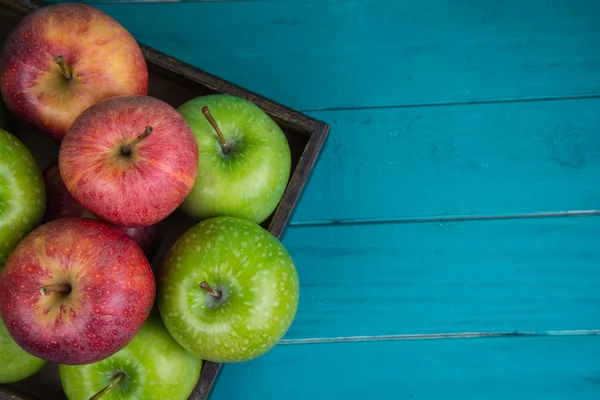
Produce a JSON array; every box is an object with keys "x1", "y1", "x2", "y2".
[{"x1": 178, "y1": 94, "x2": 291, "y2": 224}]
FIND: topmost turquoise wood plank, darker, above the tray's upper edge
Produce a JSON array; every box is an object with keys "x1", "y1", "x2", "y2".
[{"x1": 71, "y1": 0, "x2": 600, "y2": 110}]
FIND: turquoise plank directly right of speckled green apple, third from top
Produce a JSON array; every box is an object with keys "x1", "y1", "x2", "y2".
[{"x1": 283, "y1": 217, "x2": 600, "y2": 339}]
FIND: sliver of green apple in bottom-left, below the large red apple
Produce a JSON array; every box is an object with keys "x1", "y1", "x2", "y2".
[{"x1": 0, "y1": 310, "x2": 46, "y2": 383}]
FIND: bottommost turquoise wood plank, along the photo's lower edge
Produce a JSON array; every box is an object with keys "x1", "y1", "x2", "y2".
[{"x1": 210, "y1": 336, "x2": 600, "y2": 400}]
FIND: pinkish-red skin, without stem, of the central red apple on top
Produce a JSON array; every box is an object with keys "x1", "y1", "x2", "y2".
[{"x1": 59, "y1": 96, "x2": 198, "y2": 227}]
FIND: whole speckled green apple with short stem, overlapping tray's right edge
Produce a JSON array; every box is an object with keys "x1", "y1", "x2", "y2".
[{"x1": 157, "y1": 217, "x2": 299, "y2": 362}]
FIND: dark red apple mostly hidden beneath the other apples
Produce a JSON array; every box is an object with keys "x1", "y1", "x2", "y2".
[{"x1": 43, "y1": 161, "x2": 165, "y2": 260}]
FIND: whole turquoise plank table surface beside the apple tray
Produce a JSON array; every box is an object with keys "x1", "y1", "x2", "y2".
[{"x1": 54, "y1": 0, "x2": 600, "y2": 400}]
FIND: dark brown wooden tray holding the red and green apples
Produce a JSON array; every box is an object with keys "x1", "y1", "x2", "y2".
[{"x1": 0, "y1": 0, "x2": 329, "y2": 400}]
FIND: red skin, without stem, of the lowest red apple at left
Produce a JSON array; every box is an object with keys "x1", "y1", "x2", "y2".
[{"x1": 0, "y1": 218, "x2": 156, "y2": 364}]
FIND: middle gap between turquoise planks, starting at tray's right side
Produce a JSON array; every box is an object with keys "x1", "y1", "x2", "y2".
[{"x1": 288, "y1": 210, "x2": 600, "y2": 228}]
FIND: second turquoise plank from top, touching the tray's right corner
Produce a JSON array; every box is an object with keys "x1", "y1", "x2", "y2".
[{"x1": 292, "y1": 97, "x2": 600, "y2": 224}]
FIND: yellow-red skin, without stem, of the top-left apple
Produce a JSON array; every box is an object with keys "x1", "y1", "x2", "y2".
[{"x1": 0, "y1": 3, "x2": 148, "y2": 141}]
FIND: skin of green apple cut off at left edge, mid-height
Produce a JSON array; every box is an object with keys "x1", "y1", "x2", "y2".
[{"x1": 0, "y1": 129, "x2": 46, "y2": 269}]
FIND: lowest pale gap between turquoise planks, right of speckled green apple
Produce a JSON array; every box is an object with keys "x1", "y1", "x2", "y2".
[{"x1": 278, "y1": 329, "x2": 600, "y2": 345}]
